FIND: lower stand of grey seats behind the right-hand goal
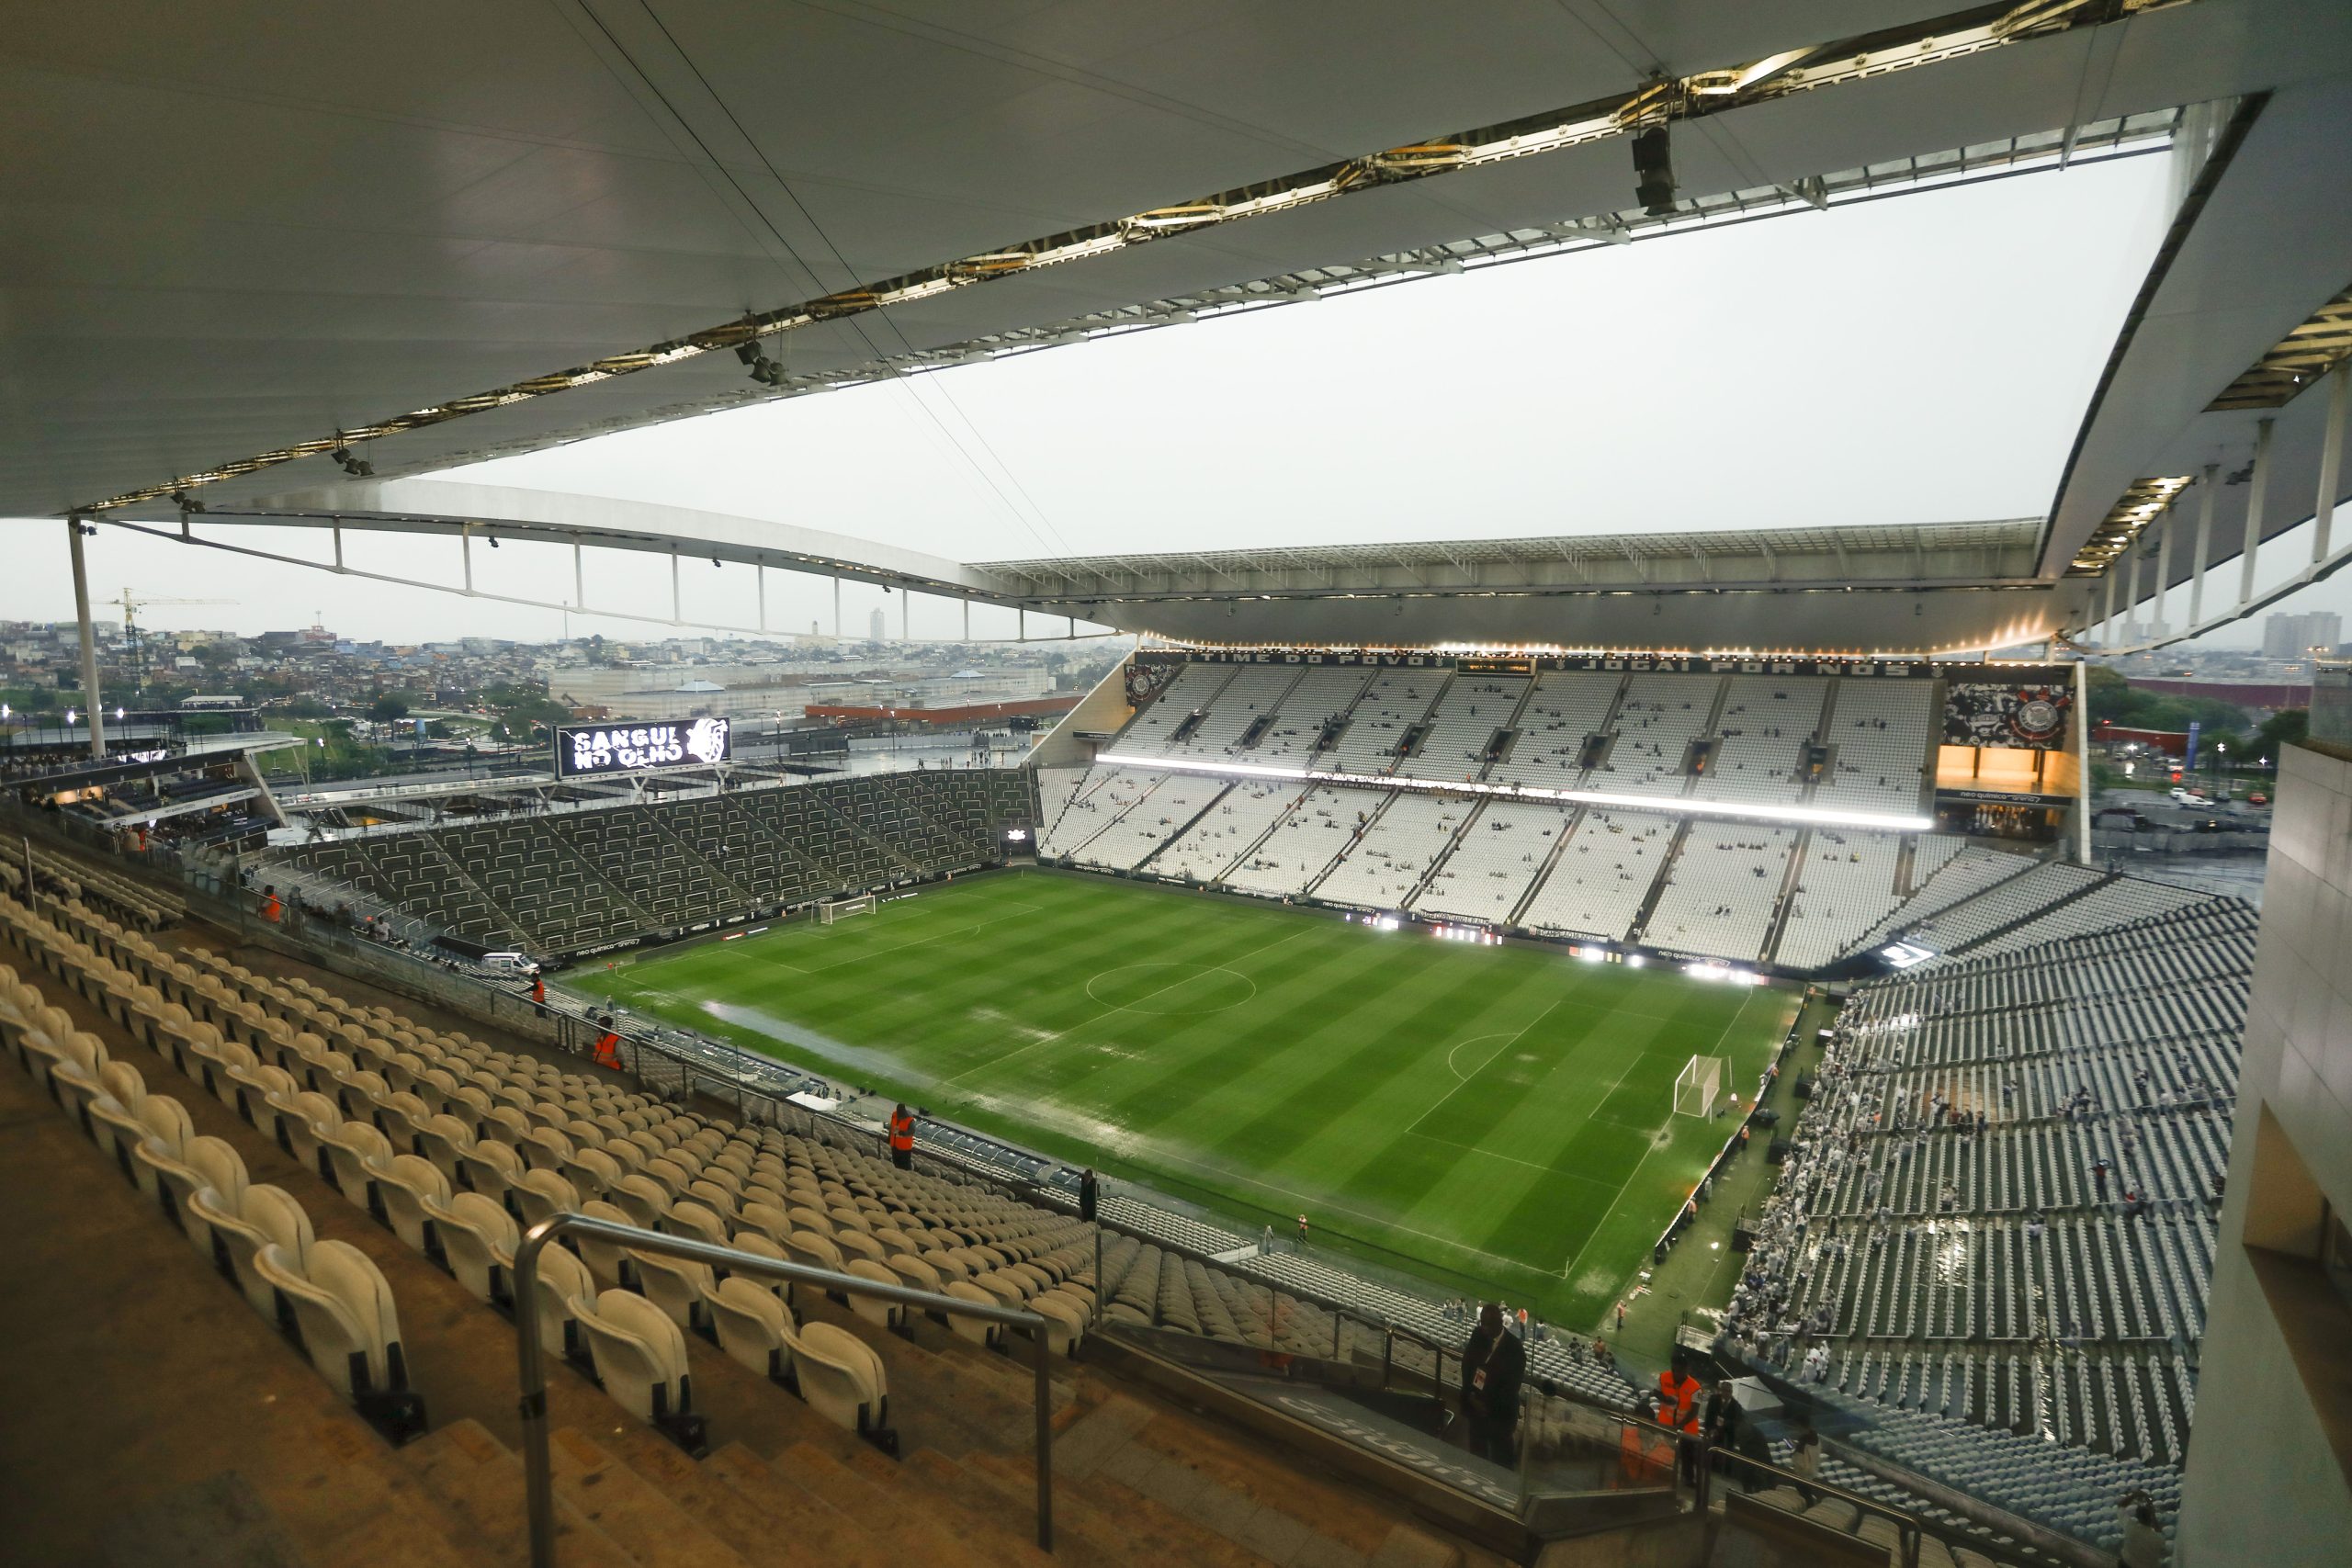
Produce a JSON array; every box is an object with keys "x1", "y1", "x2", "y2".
[{"x1": 1724, "y1": 893, "x2": 2256, "y2": 1551}]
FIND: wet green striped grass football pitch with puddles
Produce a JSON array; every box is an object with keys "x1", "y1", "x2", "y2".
[{"x1": 574, "y1": 872, "x2": 1797, "y2": 1325}]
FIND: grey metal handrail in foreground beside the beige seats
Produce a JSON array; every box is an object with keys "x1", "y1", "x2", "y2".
[{"x1": 515, "y1": 1211, "x2": 1054, "y2": 1568}]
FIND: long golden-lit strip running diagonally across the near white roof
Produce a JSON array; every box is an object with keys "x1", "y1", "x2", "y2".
[{"x1": 73, "y1": 0, "x2": 2197, "y2": 514}]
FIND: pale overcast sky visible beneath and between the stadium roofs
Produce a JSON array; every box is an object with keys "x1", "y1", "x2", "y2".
[{"x1": 0, "y1": 157, "x2": 2352, "y2": 642}]
